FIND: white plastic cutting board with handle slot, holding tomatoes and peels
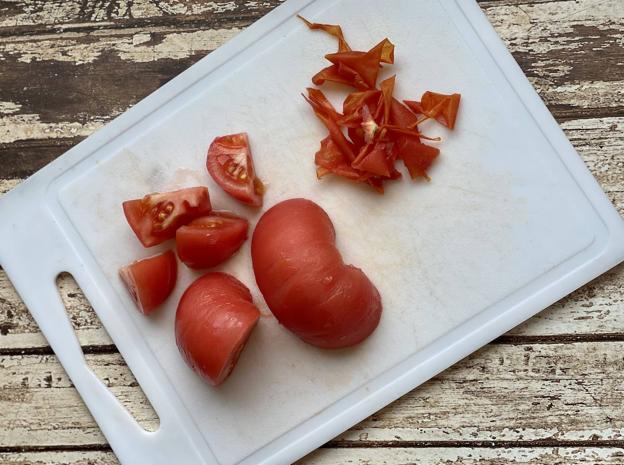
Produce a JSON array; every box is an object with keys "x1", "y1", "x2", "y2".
[{"x1": 0, "y1": 0, "x2": 624, "y2": 465}]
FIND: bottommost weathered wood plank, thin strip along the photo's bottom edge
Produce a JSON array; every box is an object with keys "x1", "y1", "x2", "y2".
[{"x1": 0, "y1": 447, "x2": 624, "y2": 465}]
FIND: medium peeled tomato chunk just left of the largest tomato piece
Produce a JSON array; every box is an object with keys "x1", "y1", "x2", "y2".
[{"x1": 175, "y1": 273, "x2": 260, "y2": 386}]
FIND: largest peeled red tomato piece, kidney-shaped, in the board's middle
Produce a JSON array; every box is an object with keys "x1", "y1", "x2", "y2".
[{"x1": 251, "y1": 199, "x2": 382, "y2": 349}]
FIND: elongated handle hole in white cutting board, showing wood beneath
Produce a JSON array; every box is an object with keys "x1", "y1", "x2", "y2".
[{"x1": 56, "y1": 273, "x2": 160, "y2": 431}]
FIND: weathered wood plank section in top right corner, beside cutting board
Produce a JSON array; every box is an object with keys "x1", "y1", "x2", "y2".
[{"x1": 482, "y1": 0, "x2": 624, "y2": 117}]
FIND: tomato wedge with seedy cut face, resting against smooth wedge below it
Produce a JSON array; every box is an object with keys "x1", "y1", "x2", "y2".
[{"x1": 123, "y1": 187, "x2": 212, "y2": 247}]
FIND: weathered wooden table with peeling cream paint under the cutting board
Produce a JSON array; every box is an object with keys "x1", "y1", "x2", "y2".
[{"x1": 0, "y1": 0, "x2": 624, "y2": 465}]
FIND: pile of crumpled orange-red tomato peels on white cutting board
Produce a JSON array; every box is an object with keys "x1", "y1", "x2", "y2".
[{"x1": 299, "y1": 16, "x2": 461, "y2": 193}]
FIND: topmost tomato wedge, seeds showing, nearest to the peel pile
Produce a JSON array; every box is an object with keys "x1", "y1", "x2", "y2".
[{"x1": 206, "y1": 132, "x2": 264, "y2": 207}]
